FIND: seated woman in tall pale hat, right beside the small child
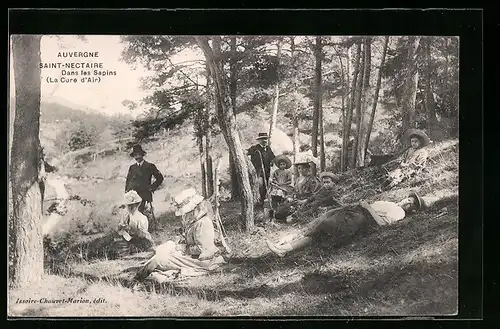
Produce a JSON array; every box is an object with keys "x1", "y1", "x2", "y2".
[{"x1": 274, "y1": 153, "x2": 322, "y2": 223}]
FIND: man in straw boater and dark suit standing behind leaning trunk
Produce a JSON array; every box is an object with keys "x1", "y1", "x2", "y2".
[{"x1": 247, "y1": 133, "x2": 274, "y2": 206}]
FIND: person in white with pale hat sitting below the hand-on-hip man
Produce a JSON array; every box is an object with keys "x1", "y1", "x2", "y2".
[{"x1": 118, "y1": 191, "x2": 155, "y2": 249}]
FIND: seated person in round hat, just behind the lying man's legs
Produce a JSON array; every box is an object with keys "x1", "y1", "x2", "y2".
[{"x1": 296, "y1": 171, "x2": 342, "y2": 218}]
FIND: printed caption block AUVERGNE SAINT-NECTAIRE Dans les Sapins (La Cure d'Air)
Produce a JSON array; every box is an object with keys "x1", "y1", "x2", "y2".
[{"x1": 39, "y1": 51, "x2": 117, "y2": 83}]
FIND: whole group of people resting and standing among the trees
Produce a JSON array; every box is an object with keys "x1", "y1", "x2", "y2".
[{"x1": 118, "y1": 130, "x2": 435, "y2": 280}]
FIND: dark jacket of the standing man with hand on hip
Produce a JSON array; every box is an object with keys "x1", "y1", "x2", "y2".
[{"x1": 125, "y1": 160, "x2": 163, "y2": 202}]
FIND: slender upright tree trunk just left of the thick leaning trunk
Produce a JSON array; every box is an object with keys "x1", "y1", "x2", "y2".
[{"x1": 205, "y1": 66, "x2": 215, "y2": 197}]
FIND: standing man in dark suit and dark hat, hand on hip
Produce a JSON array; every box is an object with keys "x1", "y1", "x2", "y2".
[{"x1": 125, "y1": 145, "x2": 163, "y2": 232}]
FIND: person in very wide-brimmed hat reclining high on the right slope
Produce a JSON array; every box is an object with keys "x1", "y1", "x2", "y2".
[{"x1": 382, "y1": 129, "x2": 430, "y2": 189}]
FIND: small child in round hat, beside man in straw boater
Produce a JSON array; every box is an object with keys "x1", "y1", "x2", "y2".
[{"x1": 269, "y1": 154, "x2": 293, "y2": 210}]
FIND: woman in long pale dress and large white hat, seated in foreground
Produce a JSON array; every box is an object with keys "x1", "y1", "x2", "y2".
[{"x1": 136, "y1": 189, "x2": 225, "y2": 280}]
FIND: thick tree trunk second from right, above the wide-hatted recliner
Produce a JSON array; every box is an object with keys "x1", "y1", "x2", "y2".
[{"x1": 401, "y1": 36, "x2": 420, "y2": 133}]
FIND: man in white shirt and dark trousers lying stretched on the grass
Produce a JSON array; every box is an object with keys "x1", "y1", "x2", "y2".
[{"x1": 266, "y1": 192, "x2": 436, "y2": 257}]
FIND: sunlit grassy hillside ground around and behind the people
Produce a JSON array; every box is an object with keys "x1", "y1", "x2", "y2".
[{"x1": 10, "y1": 120, "x2": 458, "y2": 316}]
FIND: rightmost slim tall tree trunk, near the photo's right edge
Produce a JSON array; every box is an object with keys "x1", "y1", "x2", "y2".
[{"x1": 422, "y1": 38, "x2": 439, "y2": 140}]
